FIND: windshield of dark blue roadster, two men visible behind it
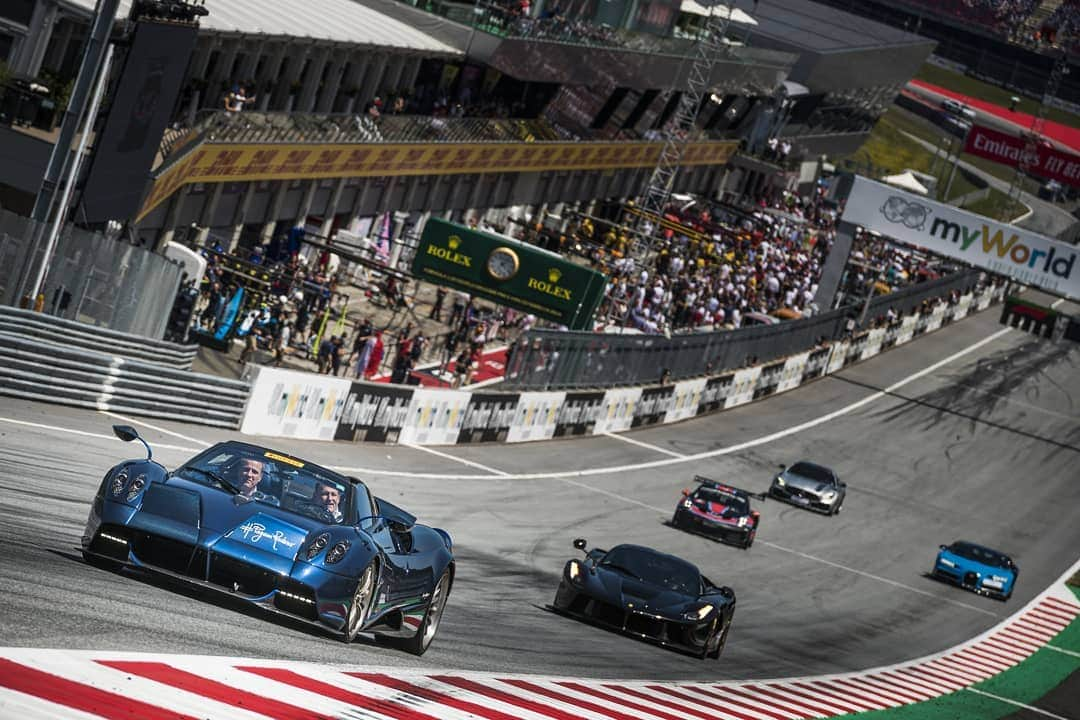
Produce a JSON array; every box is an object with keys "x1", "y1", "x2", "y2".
[{"x1": 176, "y1": 444, "x2": 370, "y2": 525}]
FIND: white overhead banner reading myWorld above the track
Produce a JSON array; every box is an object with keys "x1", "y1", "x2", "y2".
[{"x1": 842, "y1": 176, "x2": 1080, "y2": 300}]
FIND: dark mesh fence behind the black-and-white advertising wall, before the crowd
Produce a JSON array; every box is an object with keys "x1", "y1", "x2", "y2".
[{"x1": 504, "y1": 271, "x2": 980, "y2": 390}]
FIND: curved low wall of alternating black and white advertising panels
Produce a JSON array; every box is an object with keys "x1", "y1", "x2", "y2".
[{"x1": 241, "y1": 286, "x2": 1004, "y2": 445}]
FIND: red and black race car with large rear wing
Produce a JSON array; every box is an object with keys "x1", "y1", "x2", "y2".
[{"x1": 672, "y1": 475, "x2": 765, "y2": 549}]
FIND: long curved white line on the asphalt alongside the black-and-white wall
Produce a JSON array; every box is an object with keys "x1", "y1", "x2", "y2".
[{"x1": 332, "y1": 327, "x2": 1012, "y2": 480}]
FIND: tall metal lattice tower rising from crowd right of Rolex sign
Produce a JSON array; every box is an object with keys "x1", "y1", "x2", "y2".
[{"x1": 607, "y1": 0, "x2": 734, "y2": 322}]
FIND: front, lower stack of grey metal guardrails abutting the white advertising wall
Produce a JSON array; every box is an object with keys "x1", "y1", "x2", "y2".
[{"x1": 0, "y1": 331, "x2": 249, "y2": 429}]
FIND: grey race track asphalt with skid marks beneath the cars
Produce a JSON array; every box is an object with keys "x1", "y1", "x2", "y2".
[{"x1": 0, "y1": 293, "x2": 1080, "y2": 680}]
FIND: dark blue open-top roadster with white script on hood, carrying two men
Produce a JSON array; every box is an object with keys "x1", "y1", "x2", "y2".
[{"x1": 82, "y1": 425, "x2": 455, "y2": 655}]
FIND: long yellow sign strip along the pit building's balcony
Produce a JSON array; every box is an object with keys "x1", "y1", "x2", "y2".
[{"x1": 136, "y1": 140, "x2": 738, "y2": 220}]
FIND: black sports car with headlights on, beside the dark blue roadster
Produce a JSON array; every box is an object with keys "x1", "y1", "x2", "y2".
[{"x1": 553, "y1": 539, "x2": 735, "y2": 660}]
